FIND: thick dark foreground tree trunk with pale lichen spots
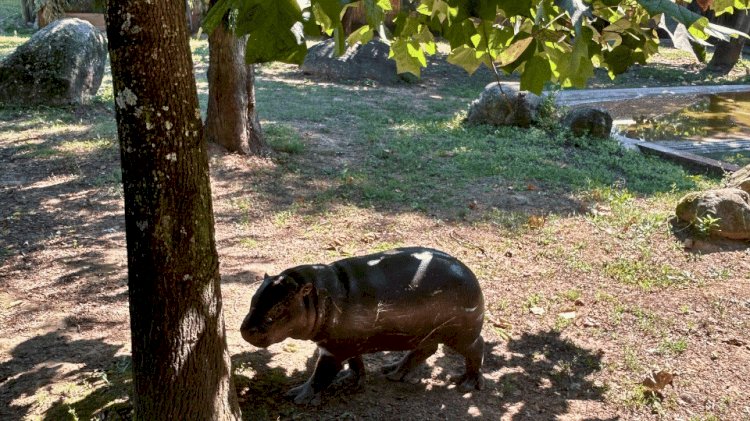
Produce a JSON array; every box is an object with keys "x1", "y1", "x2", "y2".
[{"x1": 107, "y1": 0, "x2": 240, "y2": 420}]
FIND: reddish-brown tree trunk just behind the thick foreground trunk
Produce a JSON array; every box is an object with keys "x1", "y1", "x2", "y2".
[{"x1": 206, "y1": 25, "x2": 266, "y2": 155}]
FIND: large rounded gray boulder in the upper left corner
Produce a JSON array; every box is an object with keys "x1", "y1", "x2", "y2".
[{"x1": 0, "y1": 19, "x2": 107, "y2": 105}]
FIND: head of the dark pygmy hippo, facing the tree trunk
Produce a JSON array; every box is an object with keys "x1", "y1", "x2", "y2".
[{"x1": 240, "y1": 270, "x2": 314, "y2": 348}]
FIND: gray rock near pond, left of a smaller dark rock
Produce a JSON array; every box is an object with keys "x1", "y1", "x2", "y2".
[{"x1": 466, "y1": 82, "x2": 542, "y2": 127}]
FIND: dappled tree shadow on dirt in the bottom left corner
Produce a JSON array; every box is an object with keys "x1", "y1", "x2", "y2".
[{"x1": 0, "y1": 332, "x2": 130, "y2": 420}]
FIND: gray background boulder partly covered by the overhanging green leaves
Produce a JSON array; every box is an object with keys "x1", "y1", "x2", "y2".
[{"x1": 302, "y1": 39, "x2": 402, "y2": 83}]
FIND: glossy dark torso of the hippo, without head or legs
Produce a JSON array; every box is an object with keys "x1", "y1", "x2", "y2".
[{"x1": 330, "y1": 247, "x2": 484, "y2": 351}]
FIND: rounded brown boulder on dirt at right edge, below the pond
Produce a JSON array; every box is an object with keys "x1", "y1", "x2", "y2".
[{"x1": 676, "y1": 188, "x2": 750, "y2": 240}]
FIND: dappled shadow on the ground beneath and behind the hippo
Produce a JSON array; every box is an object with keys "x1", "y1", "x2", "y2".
[{"x1": 232, "y1": 331, "x2": 617, "y2": 421}]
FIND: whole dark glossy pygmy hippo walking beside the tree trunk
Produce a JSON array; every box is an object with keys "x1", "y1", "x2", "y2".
[{"x1": 240, "y1": 247, "x2": 484, "y2": 405}]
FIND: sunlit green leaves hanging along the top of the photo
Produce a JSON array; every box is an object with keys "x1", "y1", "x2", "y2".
[{"x1": 204, "y1": 0, "x2": 750, "y2": 93}]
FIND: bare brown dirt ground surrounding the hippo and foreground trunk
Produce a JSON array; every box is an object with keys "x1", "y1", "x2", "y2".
[{"x1": 0, "y1": 50, "x2": 750, "y2": 420}]
